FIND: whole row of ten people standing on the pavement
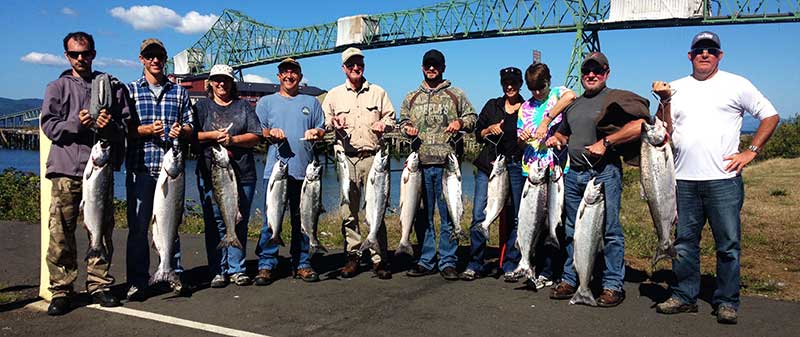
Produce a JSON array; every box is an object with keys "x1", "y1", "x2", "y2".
[{"x1": 41, "y1": 32, "x2": 778, "y2": 323}]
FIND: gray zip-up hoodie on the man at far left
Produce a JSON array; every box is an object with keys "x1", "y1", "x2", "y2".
[{"x1": 39, "y1": 69, "x2": 130, "y2": 178}]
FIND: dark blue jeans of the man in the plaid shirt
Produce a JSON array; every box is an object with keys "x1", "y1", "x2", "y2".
[{"x1": 125, "y1": 171, "x2": 183, "y2": 288}]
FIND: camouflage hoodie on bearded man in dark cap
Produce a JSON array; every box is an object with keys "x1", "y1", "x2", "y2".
[{"x1": 400, "y1": 80, "x2": 477, "y2": 165}]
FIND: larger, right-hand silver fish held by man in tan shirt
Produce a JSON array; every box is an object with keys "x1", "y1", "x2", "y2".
[{"x1": 361, "y1": 150, "x2": 390, "y2": 251}]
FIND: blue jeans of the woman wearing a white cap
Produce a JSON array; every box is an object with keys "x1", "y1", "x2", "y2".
[{"x1": 197, "y1": 172, "x2": 256, "y2": 275}]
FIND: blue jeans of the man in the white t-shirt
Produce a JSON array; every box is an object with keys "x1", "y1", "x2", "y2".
[{"x1": 672, "y1": 176, "x2": 744, "y2": 309}]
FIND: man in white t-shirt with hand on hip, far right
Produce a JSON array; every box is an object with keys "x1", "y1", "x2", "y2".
[{"x1": 653, "y1": 31, "x2": 779, "y2": 324}]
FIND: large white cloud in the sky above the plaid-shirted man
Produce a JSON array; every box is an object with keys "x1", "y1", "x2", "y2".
[{"x1": 109, "y1": 5, "x2": 218, "y2": 34}]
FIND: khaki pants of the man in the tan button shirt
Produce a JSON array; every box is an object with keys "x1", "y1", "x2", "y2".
[{"x1": 342, "y1": 156, "x2": 388, "y2": 263}]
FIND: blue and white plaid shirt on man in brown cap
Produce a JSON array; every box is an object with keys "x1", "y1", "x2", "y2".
[{"x1": 125, "y1": 77, "x2": 193, "y2": 177}]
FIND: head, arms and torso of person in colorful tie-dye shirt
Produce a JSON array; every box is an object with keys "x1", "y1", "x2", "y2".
[{"x1": 517, "y1": 63, "x2": 576, "y2": 176}]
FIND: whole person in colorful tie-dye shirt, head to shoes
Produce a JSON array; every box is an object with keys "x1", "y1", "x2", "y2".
[{"x1": 517, "y1": 63, "x2": 575, "y2": 289}]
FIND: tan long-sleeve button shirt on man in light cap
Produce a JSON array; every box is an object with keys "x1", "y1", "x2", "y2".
[{"x1": 322, "y1": 81, "x2": 395, "y2": 153}]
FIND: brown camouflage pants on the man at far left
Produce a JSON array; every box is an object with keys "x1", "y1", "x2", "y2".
[{"x1": 47, "y1": 177, "x2": 114, "y2": 297}]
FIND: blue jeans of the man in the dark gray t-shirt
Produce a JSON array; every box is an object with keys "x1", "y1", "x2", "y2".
[{"x1": 562, "y1": 164, "x2": 625, "y2": 291}]
